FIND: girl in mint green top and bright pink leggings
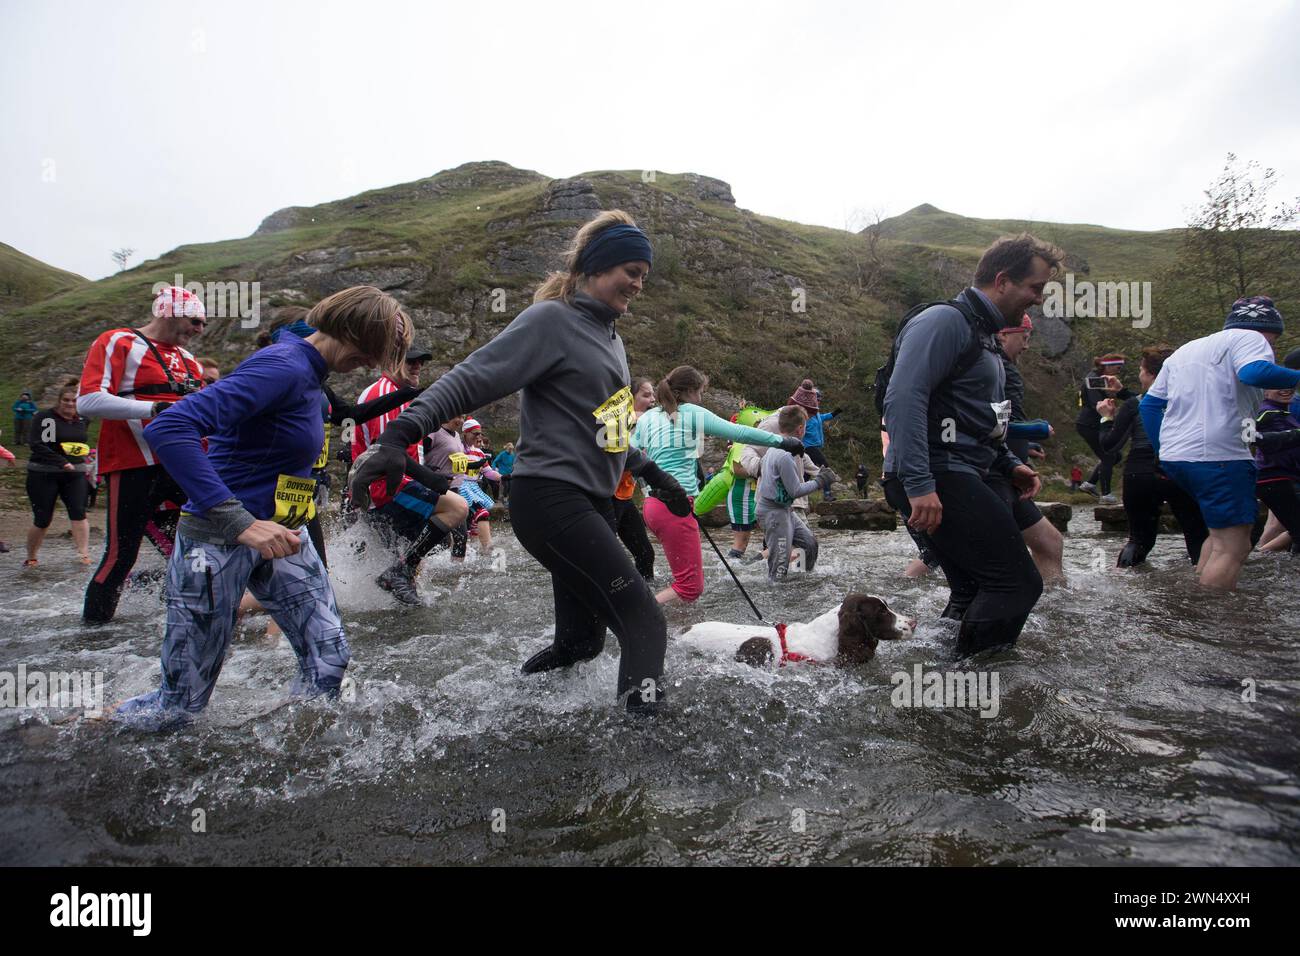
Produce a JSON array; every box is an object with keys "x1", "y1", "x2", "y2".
[{"x1": 632, "y1": 365, "x2": 803, "y2": 604}]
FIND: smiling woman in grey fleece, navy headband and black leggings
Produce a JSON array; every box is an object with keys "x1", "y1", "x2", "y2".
[{"x1": 351, "y1": 209, "x2": 690, "y2": 711}]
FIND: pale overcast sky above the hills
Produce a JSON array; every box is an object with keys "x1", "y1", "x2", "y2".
[{"x1": 0, "y1": 0, "x2": 1300, "y2": 278}]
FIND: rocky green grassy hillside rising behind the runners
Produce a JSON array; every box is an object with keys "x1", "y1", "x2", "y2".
[{"x1": 0, "y1": 163, "x2": 1300, "y2": 494}]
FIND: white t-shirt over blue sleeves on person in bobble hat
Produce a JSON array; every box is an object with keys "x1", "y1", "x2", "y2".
[{"x1": 1148, "y1": 329, "x2": 1275, "y2": 462}]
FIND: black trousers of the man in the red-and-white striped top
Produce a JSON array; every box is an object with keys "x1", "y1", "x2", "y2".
[{"x1": 82, "y1": 464, "x2": 186, "y2": 624}]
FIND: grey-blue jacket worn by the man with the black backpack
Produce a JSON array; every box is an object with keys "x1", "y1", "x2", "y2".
[{"x1": 885, "y1": 289, "x2": 1022, "y2": 498}]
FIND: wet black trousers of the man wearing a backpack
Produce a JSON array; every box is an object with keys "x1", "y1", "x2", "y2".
[{"x1": 885, "y1": 471, "x2": 1043, "y2": 657}]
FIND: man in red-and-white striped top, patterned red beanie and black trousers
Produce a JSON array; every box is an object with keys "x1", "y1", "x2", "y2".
[{"x1": 77, "y1": 286, "x2": 207, "y2": 624}]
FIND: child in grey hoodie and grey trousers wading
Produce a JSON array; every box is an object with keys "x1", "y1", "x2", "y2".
[{"x1": 757, "y1": 406, "x2": 835, "y2": 583}]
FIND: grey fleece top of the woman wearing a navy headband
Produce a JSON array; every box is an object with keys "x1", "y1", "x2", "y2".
[{"x1": 380, "y1": 293, "x2": 647, "y2": 498}]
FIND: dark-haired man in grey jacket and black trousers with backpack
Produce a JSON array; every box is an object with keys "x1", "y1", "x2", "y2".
[{"x1": 884, "y1": 234, "x2": 1063, "y2": 657}]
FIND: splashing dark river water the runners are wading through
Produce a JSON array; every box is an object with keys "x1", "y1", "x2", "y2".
[{"x1": 0, "y1": 512, "x2": 1300, "y2": 865}]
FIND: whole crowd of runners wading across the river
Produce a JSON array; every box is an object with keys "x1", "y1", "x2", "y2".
[{"x1": 0, "y1": 211, "x2": 1300, "y2": 728}]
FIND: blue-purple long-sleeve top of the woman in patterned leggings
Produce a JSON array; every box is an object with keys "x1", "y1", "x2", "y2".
[{"x1": 144, "y1": 336, "x2": 329, "y2": 519}]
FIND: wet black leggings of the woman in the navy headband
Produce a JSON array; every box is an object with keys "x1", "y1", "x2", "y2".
[{"x1": 510, "y1": 477, "x2": 668, "y2": 697}]
